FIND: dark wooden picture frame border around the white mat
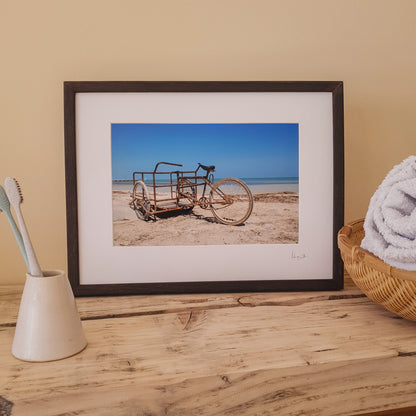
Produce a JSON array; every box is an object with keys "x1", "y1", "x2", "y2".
[{"x1": 64, "y1": 81, "x2": 344, "y2": 296}]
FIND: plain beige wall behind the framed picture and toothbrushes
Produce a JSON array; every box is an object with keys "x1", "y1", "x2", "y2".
[{"x1": 0, "y1": 0, "x2": 416, "y2": 283}]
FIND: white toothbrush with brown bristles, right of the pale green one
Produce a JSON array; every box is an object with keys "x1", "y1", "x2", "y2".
[{"x1": 4, "y1": 178, "x2": 43, "y2": 276}]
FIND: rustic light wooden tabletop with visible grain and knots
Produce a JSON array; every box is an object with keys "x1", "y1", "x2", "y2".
[{"x1": 0, "y1": 280, "x2": 416, "y2": 416}]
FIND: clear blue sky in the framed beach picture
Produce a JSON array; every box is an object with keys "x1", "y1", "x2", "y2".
[{"x1": 111, "y1": 124, "x2": 299, "y2": 179}]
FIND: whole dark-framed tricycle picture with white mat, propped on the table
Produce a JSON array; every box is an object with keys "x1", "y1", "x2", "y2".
[{"x1": 64, "y1": 81, "x2": 344, "y2": 296}]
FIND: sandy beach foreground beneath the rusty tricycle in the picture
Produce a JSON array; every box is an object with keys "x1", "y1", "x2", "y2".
[{"x1": 113, "y1": 190, "x2": 299, "y2": 246}]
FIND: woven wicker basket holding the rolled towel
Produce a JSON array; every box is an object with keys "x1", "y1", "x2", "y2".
[{"x1": 338, "y1": 219, "x2": 416, "y2": 321}]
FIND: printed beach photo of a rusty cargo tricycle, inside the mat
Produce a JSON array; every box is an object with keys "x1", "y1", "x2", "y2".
[{"x1": 111, "y1": 123, "x2": 299, "y2": 246}]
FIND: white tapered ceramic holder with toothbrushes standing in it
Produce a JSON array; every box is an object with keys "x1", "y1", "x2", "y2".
[{"x1": 12, "y1": 270, "x2": 87, "y2": 361}]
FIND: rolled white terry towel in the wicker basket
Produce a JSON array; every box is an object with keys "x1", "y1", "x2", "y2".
[{"x1": 361, "y1": 156, "x2": 416, "y2": 270}]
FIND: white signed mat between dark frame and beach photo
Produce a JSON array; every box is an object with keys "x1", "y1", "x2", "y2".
[{"x1": 75, "y1": 92, "x2": 334, "y2": 285}]
